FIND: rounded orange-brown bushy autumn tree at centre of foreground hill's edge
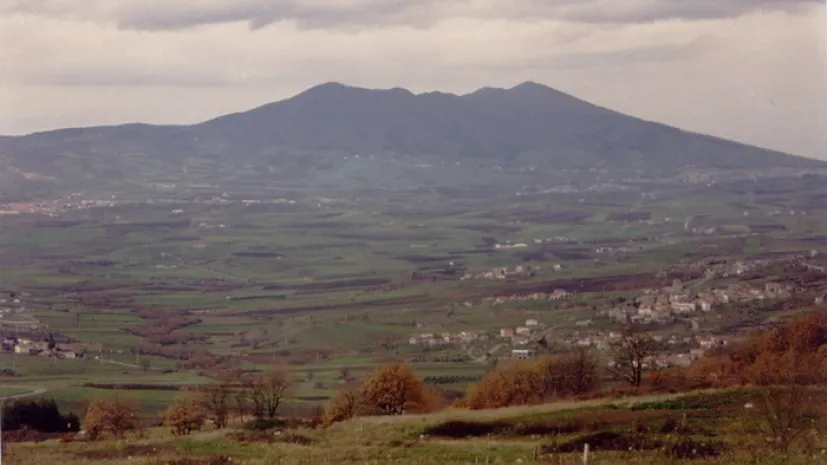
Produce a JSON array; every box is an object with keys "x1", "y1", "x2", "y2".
[{"x1": 359, "y1": 362, "x2": 424, "y2": 415}]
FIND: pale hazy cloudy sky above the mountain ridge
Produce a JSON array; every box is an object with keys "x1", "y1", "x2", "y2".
[{"x1": 0, "y1": 0, "x2": 827, "y2": 159}]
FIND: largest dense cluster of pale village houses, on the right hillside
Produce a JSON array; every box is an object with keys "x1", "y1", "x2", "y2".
[{"x1": 601, "y1": 281, "x2": 792, "y2": 324}]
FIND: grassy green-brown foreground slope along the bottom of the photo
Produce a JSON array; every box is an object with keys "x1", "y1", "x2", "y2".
[{"x1": 5, "y1": 390, "x2": 827, "y2": 465}]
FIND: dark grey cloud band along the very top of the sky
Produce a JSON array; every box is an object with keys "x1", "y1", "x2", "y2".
[{"x1": 0, "y1": 0, "x2": 824, "y2": 31}]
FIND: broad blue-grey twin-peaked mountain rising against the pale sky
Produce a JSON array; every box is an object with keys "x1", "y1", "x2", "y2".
[{"x1": 0, "y1": 82, "x2": 825, "y2": 198}]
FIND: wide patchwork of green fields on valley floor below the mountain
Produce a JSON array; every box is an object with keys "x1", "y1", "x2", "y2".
[{"x1": 0, "y1": 172, "x2": 827, "y2": 414}]
